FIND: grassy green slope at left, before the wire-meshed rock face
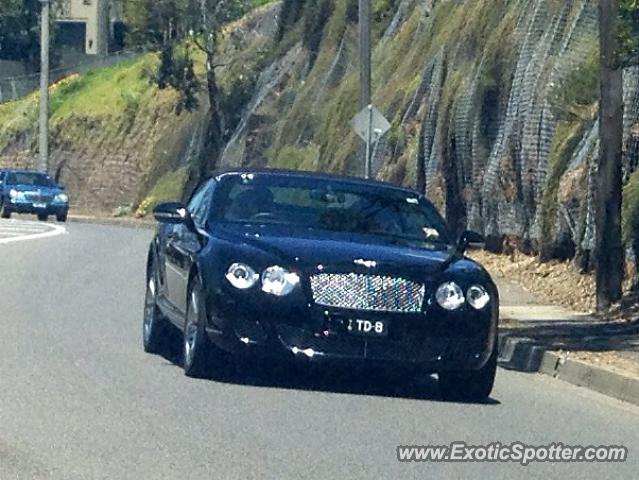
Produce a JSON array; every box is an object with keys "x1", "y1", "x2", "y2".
[{"x1": 0, "y1": 0, "x2": 280, "y2": 215}]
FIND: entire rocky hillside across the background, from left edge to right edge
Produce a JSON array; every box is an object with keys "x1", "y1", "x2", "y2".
[{"x1": 0, "y1": 0, "x2": 639, "y2": 262}]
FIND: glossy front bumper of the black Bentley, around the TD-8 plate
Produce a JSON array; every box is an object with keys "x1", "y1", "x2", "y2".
[{"x1": 208, "y1": 296, "x2": 497, "y2": 372}]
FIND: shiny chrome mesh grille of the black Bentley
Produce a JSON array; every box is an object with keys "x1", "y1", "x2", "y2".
[{"x1": 311, "y1": 273, "x2": 425, "y2": 313}]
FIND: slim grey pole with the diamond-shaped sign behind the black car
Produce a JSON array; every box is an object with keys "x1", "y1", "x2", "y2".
[{"x1": 359, "y1": 0, "x2": 372, "y2": 178}]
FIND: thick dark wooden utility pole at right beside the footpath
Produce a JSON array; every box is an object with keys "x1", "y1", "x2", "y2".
[{"x1": 595, "y1": 0, "x2": 624, "y2": 311}]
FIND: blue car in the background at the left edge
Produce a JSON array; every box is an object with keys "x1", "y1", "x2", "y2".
[{"x1": 0, "y1": 170, "x2": 69, "y2": 222}]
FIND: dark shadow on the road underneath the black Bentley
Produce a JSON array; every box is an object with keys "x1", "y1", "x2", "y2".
[{"x1": 154, "y1": 332, "x2": 500, "y2": 405}]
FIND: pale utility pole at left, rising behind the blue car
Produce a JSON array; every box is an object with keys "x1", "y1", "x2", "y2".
[{"x1": 39, "y1": 0, "x2": 51, "y2": 172}]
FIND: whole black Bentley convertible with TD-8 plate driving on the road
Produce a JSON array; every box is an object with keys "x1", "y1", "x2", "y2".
[{"x1": 143, "y1": 170, "x2": 499, "y2": 400}]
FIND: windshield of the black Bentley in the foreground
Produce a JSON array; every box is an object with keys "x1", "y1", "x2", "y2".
[{"x1": 215, "y1": 175, "x2": 448, "y2": 243}]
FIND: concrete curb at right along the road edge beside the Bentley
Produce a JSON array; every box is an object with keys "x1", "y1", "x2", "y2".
[{"x1": 499, "y1": 334, "x2": 639, "y2": 405}]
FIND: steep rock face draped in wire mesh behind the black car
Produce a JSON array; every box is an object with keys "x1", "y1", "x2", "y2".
[{"x1": 222, "y1": 0, "x2": 639, "y2": 262}]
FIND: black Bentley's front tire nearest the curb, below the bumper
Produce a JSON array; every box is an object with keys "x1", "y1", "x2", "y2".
[{"x1": 438, "y1": 348, "x2": 497, "y2": 402}]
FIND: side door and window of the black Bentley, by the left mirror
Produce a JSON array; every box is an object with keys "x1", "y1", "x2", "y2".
[{"x1": 165, "y1": 180, "x2": 213, "y2": 313}]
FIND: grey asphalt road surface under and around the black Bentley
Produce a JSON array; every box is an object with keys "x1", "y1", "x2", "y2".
[{"x1": 0, "y1": 221, "x2": 639, "y2": 480}]
